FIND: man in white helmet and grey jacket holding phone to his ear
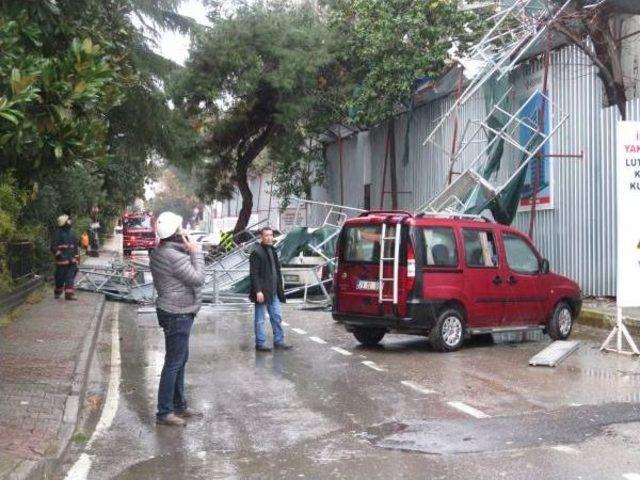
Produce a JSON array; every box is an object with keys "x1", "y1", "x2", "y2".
[{"x1": 149, "y1": 212, "x2": 205, "y2": 426}]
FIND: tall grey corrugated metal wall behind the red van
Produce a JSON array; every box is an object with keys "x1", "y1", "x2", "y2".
[{"x1": 326, "y1": 47, "x2": 640, "y2": 296}]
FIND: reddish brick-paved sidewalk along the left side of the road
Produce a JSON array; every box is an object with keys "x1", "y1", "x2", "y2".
[{"x1": 0, "y1": 239, "x2": 120, "y2": 480}]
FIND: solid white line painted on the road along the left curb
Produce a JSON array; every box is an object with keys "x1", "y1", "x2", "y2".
[{"x1": 65, "y1": 303, "x2": 122, "y2": 480}]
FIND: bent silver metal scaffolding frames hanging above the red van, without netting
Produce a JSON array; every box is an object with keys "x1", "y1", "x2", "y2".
[{"x1": 416, "y1": 0, "x2": 572, "y2": 218}]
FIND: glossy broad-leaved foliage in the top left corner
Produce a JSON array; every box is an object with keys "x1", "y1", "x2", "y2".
[{"x1": 0, "y1": 0, "x2": 127, "y2": 184}]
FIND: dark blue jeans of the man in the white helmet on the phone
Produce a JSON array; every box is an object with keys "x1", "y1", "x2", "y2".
[{"x1": 157, "y1": 309, "x2": 194, "y2": 417}]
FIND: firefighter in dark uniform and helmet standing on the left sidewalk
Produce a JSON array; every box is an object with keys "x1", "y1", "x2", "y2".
[{"x1": 51, "y1": 215, "x2": 80, "y2": 300}]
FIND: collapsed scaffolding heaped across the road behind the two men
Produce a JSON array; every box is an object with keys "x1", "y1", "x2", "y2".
[{"x1": 77, "y1": 198, "x2": 363, "y2": 307}]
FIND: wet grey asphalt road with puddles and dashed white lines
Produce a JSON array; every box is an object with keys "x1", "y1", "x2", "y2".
[{"x1": 61, "y1": 303, "x2": 640, "y2": 480}]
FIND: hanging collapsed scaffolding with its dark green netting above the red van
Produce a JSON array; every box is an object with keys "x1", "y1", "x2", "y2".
[{"x1": 416, "y1": 0, "x2": 573, "y2": 231}]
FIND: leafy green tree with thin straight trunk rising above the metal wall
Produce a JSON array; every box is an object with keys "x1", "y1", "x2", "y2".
[{"x1": 330, "y1": 0, "x2": 481, "y2": 208}]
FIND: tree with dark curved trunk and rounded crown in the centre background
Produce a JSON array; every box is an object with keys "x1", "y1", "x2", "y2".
[{"x1": 173, "y1": 3, "x2": 334, "y2": 233}]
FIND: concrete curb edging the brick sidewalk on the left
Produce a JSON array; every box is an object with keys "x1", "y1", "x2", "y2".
[{"x1": 15, "y1": 295, "x2": 106, "y2": 480}]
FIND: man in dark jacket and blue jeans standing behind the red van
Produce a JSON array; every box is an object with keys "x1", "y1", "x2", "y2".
[{"x1": 249, "y1": 227, "x2": 291, "y2": 352}]
